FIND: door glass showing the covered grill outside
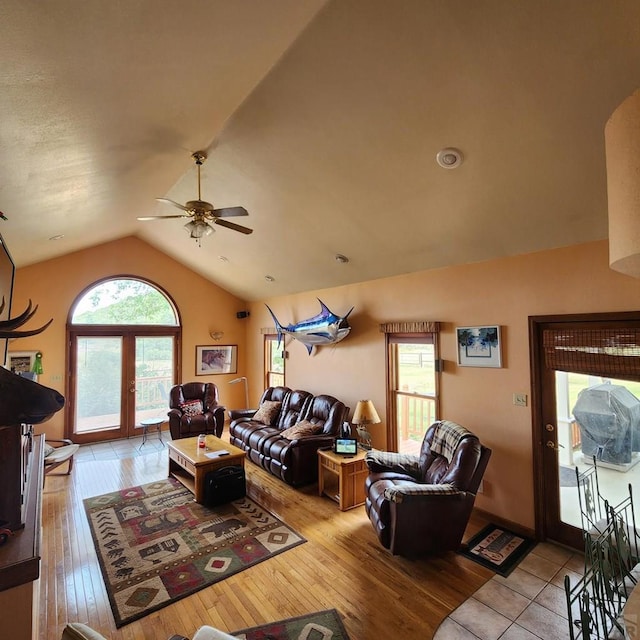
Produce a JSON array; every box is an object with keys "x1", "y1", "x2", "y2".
[{"x1": 556, "y1": 371, "x2": 640, "y2": 527}]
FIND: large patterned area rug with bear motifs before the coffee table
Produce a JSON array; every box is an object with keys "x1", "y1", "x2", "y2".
[{"x1": 84, "y1": 478, "x2": 306, "y2": 627}]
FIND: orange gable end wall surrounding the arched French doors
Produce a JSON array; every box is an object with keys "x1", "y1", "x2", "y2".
[{"x1": 9, "y1": 237, "x2": 246, "y2": 438}]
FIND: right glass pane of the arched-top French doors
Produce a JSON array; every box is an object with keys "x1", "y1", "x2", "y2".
[{"x1": 135, "y1": 336, "x2": 173, "y2": 425}]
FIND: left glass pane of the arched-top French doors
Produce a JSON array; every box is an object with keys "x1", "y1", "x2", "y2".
[{"x1": 74, "y1": 336, "x2": 122, "y2": 433}]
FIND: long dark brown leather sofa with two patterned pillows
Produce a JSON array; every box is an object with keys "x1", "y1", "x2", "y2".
[{"x1": 229, "y1": 387, "x2": 349, "y2": 486}]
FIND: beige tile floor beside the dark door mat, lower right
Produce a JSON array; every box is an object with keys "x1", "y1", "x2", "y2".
[{"x1": 434, "y1": 542, "x2": 584, "y2": 640}]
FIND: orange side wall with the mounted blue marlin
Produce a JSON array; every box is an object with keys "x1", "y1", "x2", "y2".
[{"x1": 247, "y1": 242, "x2": 640, "y2": 527}]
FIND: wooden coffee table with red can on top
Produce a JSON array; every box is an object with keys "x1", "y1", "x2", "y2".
[{"x1": 167, "y1": 436, "x2": 245, "y2": 504}]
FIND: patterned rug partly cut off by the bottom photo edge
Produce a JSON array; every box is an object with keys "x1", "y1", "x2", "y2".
[{"x1": 232, "y1": 609, "x2": 349, "y2": 640}]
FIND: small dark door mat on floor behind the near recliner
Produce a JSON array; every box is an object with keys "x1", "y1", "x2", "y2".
[{"x1": 458, "y1": 524, "x2": 536, "y2": 576}]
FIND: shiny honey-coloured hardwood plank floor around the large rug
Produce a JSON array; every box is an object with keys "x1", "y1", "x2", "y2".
[{"x1": 39, "y1": 448, "x2": 494, "y2": 640}]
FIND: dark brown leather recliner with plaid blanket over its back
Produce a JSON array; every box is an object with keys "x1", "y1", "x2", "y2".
[{"x1": 365, "y1": 420, "x2": 491, "y2": 556}]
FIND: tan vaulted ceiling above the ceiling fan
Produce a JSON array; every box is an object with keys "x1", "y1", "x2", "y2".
[{"x1": 0, "y1": 0, "x2": 640, "y2": 300}]
